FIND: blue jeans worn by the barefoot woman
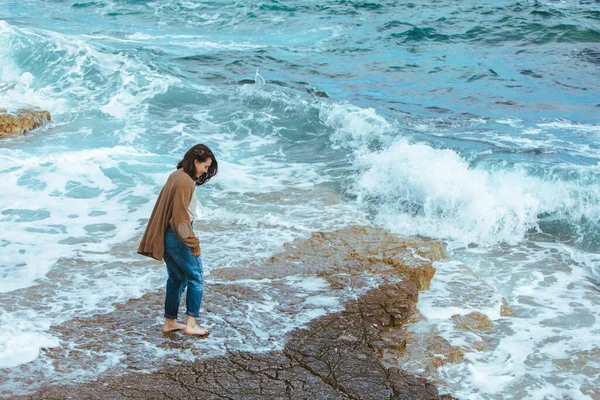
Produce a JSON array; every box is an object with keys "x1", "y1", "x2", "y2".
[{"x1": 163, "y1": 227, "x2": 204, "y2": 319}]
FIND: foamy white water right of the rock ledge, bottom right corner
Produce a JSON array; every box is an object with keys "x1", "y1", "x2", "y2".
[{"x1": 419, "y1": 242, "x2": 600, "y2": 399}]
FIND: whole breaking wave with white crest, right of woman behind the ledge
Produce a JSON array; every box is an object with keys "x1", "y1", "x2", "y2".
[{"x1": 321, "y1": 104, "x2": 600, "y2": 246}]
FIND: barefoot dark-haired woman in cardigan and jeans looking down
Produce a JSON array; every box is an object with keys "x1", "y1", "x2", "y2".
[{"x1": 138, "y1": 144, "x2": 218, "y2": 336}]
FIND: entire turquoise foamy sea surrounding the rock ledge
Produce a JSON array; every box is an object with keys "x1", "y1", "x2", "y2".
[{"x1": 0, "y1": 0, "x2": 600, "y2": 399}]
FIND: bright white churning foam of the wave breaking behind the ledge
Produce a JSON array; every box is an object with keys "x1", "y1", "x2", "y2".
[{"x1": 354, "y1": 141, "x2": 600, "y2": 244}]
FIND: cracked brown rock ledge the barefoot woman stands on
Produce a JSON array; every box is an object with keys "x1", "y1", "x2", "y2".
[{"x1": 17, "y1": 227, "x2": 456, "y2": 399}]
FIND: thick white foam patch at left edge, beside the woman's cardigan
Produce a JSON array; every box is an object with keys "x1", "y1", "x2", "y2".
[{"x1": 0, "y1": 147, "x2": 159, "y2": 292}]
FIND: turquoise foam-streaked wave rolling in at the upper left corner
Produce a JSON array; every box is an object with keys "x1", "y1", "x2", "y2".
[{"x1": 0, "y1": 21, "x2": 179, "y2": 120}]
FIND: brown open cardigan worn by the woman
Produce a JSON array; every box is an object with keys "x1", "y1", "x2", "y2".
[{"x1": 138, "y1": 168, "x2": 200, "y2": 261}]
